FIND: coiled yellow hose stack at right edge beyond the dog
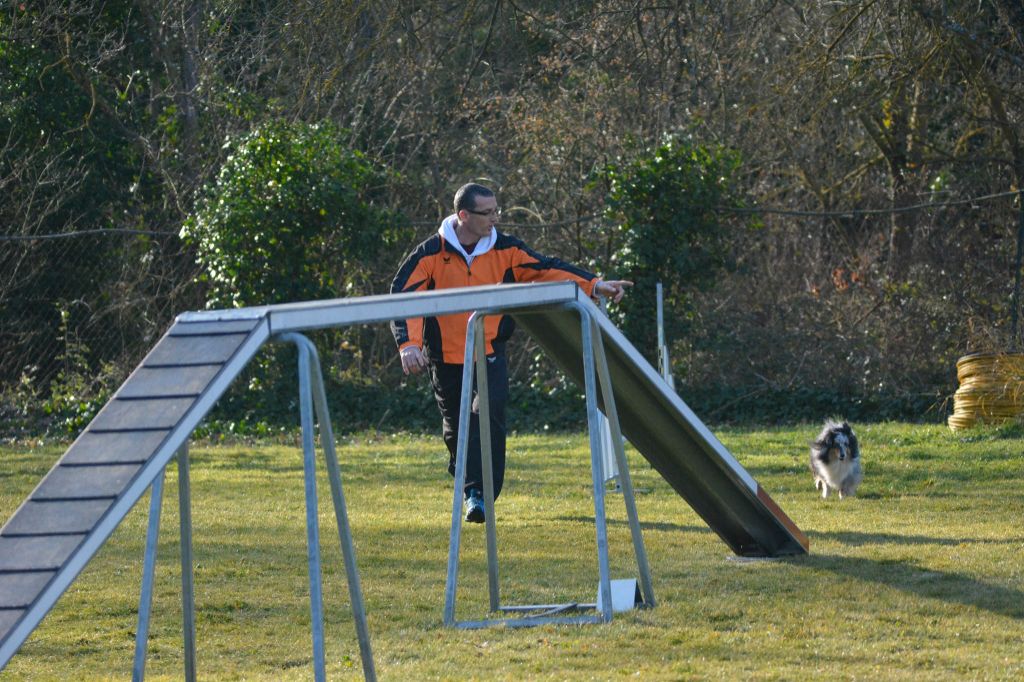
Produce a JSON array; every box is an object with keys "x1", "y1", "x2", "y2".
[{"x1": 948, "y1": 353, "x2": 1024, "y2": 431}]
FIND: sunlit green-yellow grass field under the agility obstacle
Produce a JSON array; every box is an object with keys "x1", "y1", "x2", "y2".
[{"x1": 0, "y1": 424, "x2": 1024, "y2": 680}]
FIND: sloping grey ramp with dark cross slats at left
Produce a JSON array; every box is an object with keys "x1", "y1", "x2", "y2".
[{"x1": 0, "y1": 314, "x2": 269, "y2": 668}]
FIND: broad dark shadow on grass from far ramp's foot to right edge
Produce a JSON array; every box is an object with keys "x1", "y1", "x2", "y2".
[{"x1": 783, "y1": 554, "x2": 1024, "y2": 620}]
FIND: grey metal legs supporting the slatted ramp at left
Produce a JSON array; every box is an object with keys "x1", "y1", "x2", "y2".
[{"x1": 132, "y1": 333, "x2": 377, "y2": 682}]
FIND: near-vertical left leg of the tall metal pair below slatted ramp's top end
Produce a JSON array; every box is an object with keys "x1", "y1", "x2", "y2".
[{"x1": 296, "y1": 343, "x2": 327, "y2": 682}]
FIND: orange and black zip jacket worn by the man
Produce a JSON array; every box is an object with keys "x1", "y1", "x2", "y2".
[{"x1": 391, "y1": 232, "x2": 599, "y2": 365}]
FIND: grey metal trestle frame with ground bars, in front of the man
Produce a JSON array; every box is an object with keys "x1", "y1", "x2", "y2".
[{"x1": 443, "y1": 303, "x2": 654, "y2": 629}]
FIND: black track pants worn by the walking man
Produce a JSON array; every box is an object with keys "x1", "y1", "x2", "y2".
[{"x1": 430, "y1": 352, "x2": 509, "y2": 499}]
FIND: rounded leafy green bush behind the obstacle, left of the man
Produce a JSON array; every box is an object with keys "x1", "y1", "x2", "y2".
[{"x1": 181, "y1": 121, "x2": 400, "y2": 307}]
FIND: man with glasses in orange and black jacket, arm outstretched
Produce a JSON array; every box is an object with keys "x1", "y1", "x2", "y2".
[{"x1": 391, "y1": 183, "x2": 633, "y2": 523}]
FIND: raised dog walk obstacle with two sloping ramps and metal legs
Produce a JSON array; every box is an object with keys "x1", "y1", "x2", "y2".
[{"x1": 0, "y1": 283, "x2": 807, "y2": 679}]
